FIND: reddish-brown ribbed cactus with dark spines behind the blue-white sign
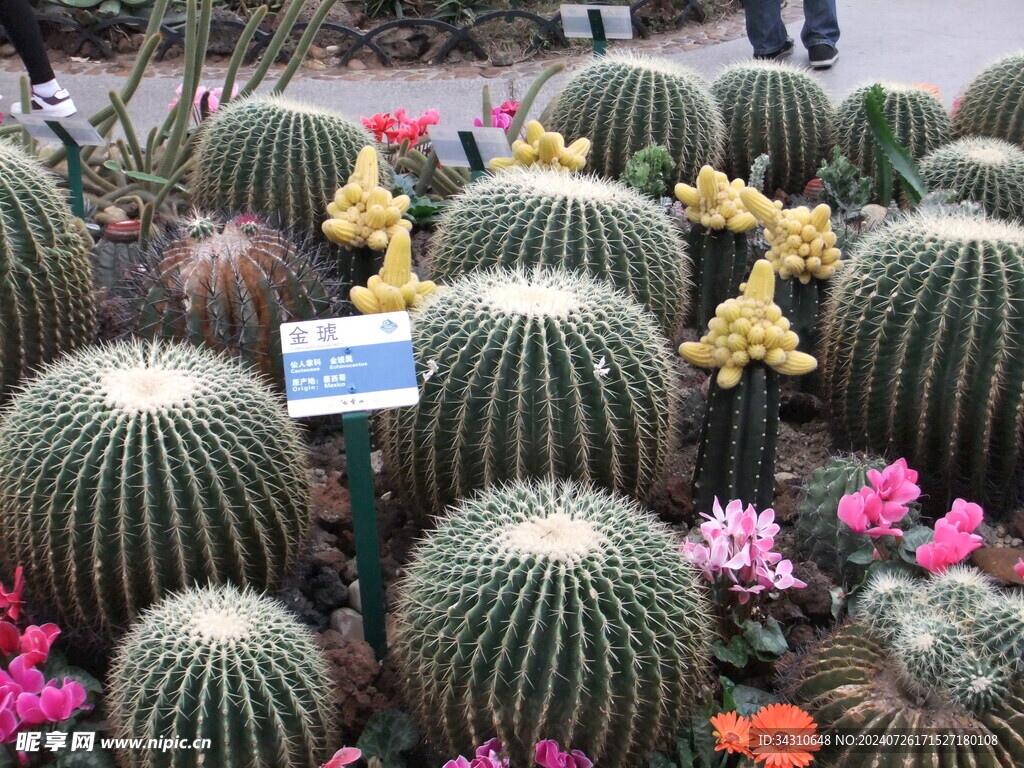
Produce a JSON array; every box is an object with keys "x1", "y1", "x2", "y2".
[{"x1": 139, "y1": 215, "x2": 332, "y2": 381}]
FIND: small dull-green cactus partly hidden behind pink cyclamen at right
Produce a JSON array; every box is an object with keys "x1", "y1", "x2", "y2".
[{"x1": 794, "y1": 456, "x2": 886, "y2": 586}]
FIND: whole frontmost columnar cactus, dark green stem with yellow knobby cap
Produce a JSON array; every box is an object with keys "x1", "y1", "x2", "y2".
[{"x1": 679, "y1": 259, "x2": 817, "y2": 512}]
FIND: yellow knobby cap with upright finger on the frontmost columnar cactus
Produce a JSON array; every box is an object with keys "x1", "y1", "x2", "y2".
[{"x1": 679, "y1": 259, "x2": 818, "y2": 389}]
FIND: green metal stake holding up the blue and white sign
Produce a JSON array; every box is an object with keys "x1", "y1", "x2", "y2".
[{"x1": 341, "y1": 411, "x2": 387, "y2": 660}]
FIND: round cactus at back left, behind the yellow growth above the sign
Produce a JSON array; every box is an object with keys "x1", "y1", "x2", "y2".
[{"x1": 193, "y1": 96, "x2": 393, "y2": 236}]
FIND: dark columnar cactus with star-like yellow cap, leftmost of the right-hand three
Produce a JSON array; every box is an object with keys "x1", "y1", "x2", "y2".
[{"x1": 675, "y1": 165, "x2": 757, "y2": 328}]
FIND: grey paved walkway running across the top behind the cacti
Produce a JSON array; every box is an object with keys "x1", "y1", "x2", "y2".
[{"x1": 0, "y1": 0, "x2": 1024, "y2": 140}]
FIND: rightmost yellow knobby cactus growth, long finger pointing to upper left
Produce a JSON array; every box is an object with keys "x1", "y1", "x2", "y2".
[{"x1": 739, "y1": 187, "x2": 843, "y2": 285}]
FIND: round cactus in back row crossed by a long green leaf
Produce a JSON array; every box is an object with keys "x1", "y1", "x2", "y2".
[{"x1": 836, "y1": 82, "x2": 953, "y2": 190}]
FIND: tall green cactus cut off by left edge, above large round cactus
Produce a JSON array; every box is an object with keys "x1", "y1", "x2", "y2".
[{"x1": 0, "y1": 142, "x2": 94, "y2": 399}]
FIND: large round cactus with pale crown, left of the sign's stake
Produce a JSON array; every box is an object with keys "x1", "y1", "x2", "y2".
[{"x1": 0, "y1": 342, "x2": 309, "y2": 634}]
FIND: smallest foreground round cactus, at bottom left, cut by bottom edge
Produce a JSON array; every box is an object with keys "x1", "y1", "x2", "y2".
[{"x1": 108, "y1": 587, "x2": 335, "y2": 768}]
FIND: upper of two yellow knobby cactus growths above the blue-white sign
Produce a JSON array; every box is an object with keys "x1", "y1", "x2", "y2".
[{"x1": 322, "y1": 145, "x2": 413, "y2": 250}]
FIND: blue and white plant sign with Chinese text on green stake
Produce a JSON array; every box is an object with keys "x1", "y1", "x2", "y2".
[{"x1": 281, "y1": 312, "x2": 420, "y2": 419}]
